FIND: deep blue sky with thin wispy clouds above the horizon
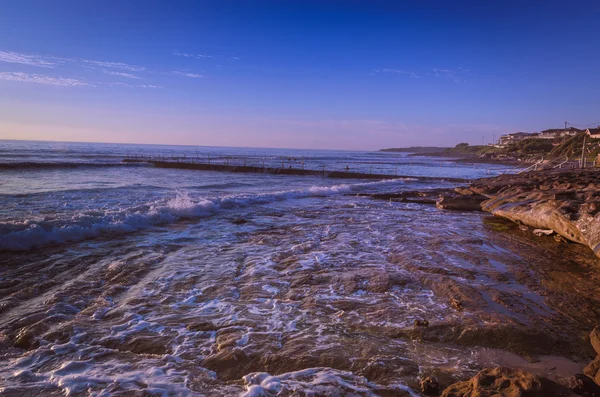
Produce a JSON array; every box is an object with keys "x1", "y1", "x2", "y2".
[{"x1": 0, "y1": 0, "x2": 600, "y2": 150}]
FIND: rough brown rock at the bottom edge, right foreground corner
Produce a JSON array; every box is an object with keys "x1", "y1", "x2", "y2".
[{"x1": 442, "y1": 367, "x2": 574, "y2": 397}]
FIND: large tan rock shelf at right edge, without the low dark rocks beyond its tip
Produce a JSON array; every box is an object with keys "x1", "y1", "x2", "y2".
[{"x1": 470, "y1": 170, "x2": 600, "y2": 256}]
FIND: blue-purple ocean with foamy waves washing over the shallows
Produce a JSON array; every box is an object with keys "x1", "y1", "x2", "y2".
[{"x1": 0, "y1": 141, "x2": 591, "y2": 396}]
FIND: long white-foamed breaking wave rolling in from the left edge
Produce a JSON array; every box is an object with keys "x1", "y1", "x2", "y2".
[{"x1": 0, "y1": 180, "x2": 402, "y2": 251}]
